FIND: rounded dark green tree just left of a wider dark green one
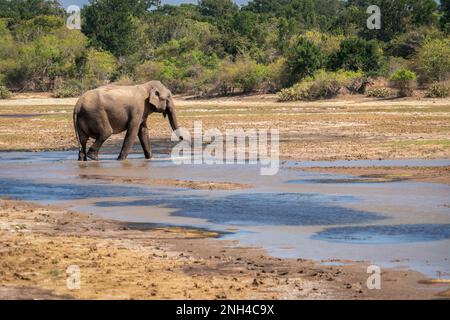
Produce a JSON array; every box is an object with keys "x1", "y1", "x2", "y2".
[{"x1": 286, "y1": 37, "x2": 323, "y2": 85}]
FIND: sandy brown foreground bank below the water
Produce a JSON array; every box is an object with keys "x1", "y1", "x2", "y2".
[{"x1": 0, "y1": 200, "x2": 450, "y2": 299}]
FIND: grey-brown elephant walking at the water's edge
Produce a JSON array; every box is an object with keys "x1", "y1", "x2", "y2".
[{"x1": 73, "y1": 81, "x2": 183, "y2": 161}]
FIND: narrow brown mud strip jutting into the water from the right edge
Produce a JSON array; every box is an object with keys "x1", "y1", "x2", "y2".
[{"x1": 289, "y1": 166, "x2": 450, "y2": 185}]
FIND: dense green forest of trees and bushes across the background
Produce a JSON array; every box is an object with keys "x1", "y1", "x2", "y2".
[{"x1": 0, "y1": 0, "x2": 450, "y2": 100}]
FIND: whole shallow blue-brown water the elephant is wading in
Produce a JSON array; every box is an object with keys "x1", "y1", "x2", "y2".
[{"x1": 0, "y1": 152, "x2": 450, "y2": 276}]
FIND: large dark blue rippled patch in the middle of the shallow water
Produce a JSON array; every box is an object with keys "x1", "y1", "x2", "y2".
[{"x1": 96, "y1": 193, "x2": 384, "y2": 226}]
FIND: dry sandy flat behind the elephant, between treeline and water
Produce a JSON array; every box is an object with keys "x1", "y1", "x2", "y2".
[{"x1": 0, "y1": 94, "x2": 450, "y2": 160}]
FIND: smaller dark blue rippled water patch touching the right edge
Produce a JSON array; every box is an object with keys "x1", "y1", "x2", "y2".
[{"x1": 312, "y1": 224, "x2": 450, "y2": 244}]
